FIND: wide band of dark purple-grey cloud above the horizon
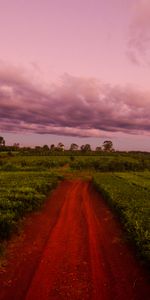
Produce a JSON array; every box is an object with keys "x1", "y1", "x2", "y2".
[{"x1": 0, "y1": 67, "x2": 150, "y2": 137}]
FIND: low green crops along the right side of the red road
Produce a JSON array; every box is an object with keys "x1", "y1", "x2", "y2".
[{"x1": 93, "y1": 172, "x2": 150, "y2": 263}]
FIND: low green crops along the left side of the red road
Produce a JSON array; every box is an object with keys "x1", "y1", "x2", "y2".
[{"x1": 0, "y1": 171, "x2": 62, "y2": 242}]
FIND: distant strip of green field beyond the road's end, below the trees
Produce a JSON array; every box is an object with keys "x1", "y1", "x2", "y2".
[{"x1": 0, "y1": 151, "x2": 150, "y2": 172}]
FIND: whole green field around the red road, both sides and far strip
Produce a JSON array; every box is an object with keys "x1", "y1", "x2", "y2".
[{"x1": 0, "y1": 153, "x2": 150, "y2": 260}]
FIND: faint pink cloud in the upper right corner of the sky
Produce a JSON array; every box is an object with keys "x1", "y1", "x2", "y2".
[{"x1": 127, "y1": 0, "x2": 150, "y2": 65}]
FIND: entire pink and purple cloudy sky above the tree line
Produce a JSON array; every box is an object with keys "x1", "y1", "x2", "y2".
[{"x1": 0, "y1": 0, "x2": 150, "y2": 151}]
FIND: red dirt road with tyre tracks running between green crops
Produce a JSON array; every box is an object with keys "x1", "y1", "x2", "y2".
[{"x1": 0, "y1": 180, "x2": 150, "y2": 300}]
